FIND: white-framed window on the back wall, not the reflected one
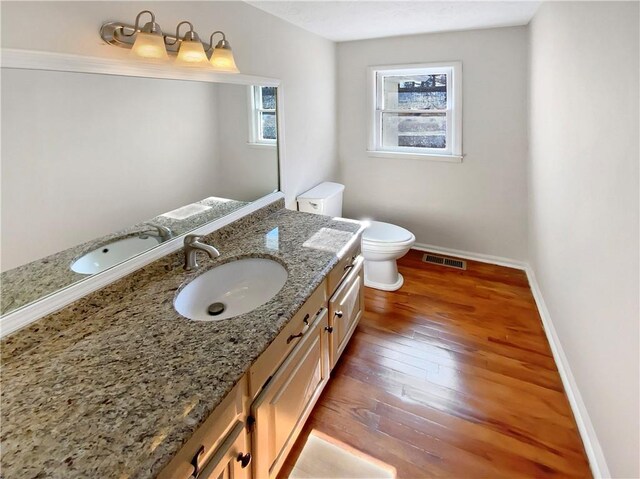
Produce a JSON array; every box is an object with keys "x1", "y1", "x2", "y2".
[{"x1": 369, "y1": 62, "x2": 462, "y2": 161}]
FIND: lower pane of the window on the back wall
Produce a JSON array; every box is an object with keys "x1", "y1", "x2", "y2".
[{"x1": 382, "y1": 113, "x2": 447, "y2": 148}]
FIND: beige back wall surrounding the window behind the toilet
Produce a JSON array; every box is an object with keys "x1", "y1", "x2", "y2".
[{"x1": 338, "y1": 27, "x2": 527, "y2": 260}]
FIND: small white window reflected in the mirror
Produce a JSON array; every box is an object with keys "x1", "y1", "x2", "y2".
[{"x1": 249, "y1": 85, "x2": 278, "y2": 146}]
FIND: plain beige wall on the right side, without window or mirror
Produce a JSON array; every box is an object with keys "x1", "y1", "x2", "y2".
[{"x1": 529, "y1": 2, "x2": 640, "y2": 478}]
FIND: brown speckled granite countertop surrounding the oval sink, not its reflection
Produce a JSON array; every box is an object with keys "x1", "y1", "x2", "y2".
[{"x1": 0, "y1": 204, "x2": 362, "y2": 478}]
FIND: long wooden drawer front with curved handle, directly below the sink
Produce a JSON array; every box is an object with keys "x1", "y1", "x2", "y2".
[{"x1": 249, "y1": 283, "x2": 327, "y2": 399}]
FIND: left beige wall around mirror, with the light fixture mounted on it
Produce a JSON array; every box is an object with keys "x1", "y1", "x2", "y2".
[{"x1": 2, "y1": 1, "x2": 337, "y2": 207}]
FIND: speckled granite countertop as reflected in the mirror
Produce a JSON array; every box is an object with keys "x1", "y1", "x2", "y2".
[{"x1": 0, "y1": 196, "x2": 248, "y2": 314}]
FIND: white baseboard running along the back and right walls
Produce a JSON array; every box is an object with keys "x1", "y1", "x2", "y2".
[{"x1": 413, "y1": 243, "x2": 611, "y2": 478}]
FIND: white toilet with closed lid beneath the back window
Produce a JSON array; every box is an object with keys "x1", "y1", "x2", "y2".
[{"x1": 298, "y1": 182, "x2": 416, "y2": 291}]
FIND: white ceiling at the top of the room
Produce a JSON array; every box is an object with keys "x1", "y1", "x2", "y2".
[{"x1": 248, "y1": 0, "x2": 541, "y2": 42}]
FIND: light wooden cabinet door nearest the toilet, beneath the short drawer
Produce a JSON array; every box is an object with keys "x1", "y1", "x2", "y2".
[{"x1": 329, "y1": 256, "x2": 364, "y2": 369}]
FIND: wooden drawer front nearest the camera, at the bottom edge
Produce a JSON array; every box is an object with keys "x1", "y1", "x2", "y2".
[{"x1": 158, "y1": 376, "x2": 248, "y2": 479}]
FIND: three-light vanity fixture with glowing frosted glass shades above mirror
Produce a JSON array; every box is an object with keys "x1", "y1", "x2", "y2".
[{"x1": 100, "y1": 10, "x2": 240, "y2": 73}]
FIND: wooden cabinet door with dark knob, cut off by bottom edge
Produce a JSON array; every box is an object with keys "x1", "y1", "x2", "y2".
[{"x1": 199, "y1": 422, "x2": 252, "y2": 479}]
